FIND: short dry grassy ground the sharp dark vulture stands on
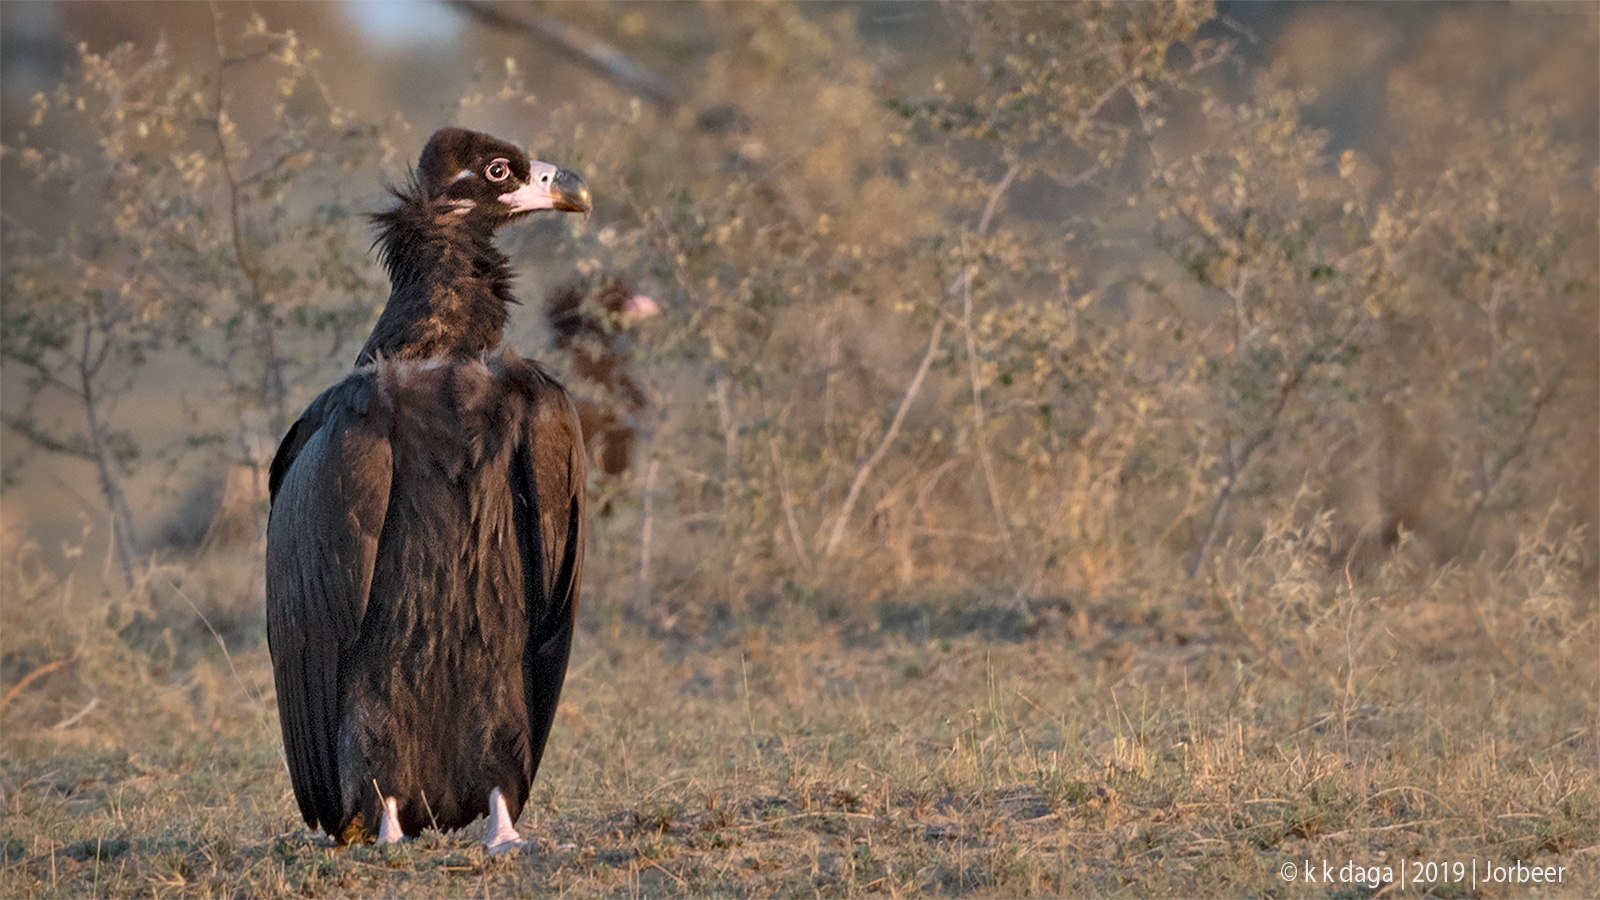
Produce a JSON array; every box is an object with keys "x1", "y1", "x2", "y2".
[{"x1": 0, "y1": 509, "x2": 1600, "y2": 897}]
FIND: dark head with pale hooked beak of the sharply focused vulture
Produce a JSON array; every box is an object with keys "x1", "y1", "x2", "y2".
[{"x1": 416, "y1": 128, "x2": 590, "y2": 229}]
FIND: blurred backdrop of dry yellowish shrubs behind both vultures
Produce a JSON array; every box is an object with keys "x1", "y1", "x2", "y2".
[{"x1": 0, "y1": 2, "x2": 1600, "y2": 634}]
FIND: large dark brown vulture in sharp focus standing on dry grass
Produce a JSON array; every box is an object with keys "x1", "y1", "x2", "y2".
[{"x1": 266, "y1": 128, "x2": 590, "y2": 852}]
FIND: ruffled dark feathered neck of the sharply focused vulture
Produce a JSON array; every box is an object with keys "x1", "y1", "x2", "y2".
[{"x1": 355, "y1": 194, "x2": 517, "y2": 365}]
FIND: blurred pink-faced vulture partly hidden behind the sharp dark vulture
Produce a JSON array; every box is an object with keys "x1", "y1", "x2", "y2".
[{"x1": 544, "y1": 275, "x2": 661, "y2": 480}]
